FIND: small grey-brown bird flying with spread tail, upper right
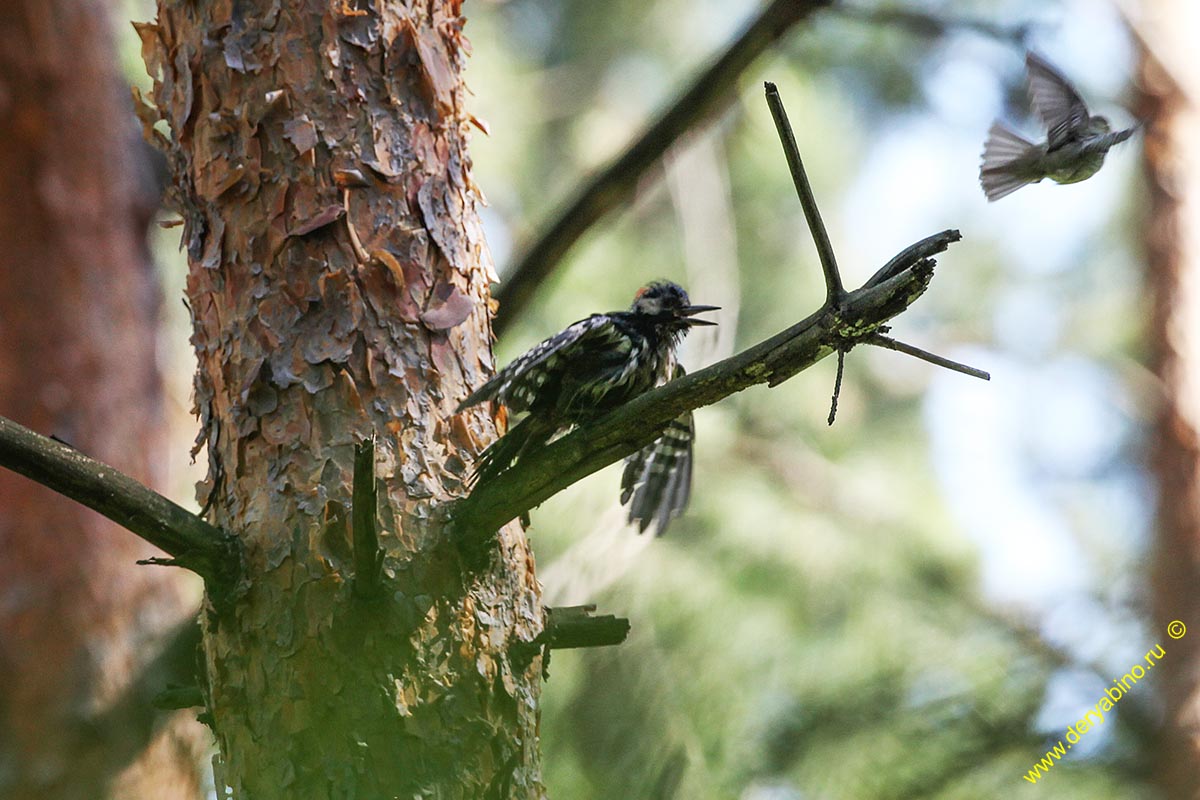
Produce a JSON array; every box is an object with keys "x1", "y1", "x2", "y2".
[{"x1": 979, "y1": 53, "x2": 1138, "y2": 203}]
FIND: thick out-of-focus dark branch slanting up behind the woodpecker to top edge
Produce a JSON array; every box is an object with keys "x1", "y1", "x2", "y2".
[{"x1": 492, "y1": 0, "x2": 830, "y2": 333}]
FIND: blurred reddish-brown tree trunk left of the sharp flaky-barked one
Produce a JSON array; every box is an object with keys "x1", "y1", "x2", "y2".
[{"x1": 0, "y1": 0, "x2": 208, "y2": 800}]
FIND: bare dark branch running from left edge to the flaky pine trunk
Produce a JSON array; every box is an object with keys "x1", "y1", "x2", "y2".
[{"x1": 0, "y1": 417, "x2": 241, "y2": 589}]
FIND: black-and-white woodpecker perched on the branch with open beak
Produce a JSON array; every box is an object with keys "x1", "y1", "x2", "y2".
[{"x1": 458, "y1": 281, "x2": 718, "y2": 535}]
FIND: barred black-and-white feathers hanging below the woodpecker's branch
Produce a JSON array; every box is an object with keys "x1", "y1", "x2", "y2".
[{"x1": 620, "y1": 411, "x2": 696, "y2": 536}]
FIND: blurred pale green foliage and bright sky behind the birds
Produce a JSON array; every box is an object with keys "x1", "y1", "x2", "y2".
[{"x1": 125, "y1": 0, "x2": 1160, "y2": 800}]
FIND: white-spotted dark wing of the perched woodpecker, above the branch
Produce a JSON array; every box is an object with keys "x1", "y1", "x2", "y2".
[{"x1": 457, "y1": 314, "x2": 614, "y2": 411}]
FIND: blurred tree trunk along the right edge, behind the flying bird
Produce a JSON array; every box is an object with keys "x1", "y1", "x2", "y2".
[{"x1": 1136, "y1": 0, "x2": 1200, "y2": 799}]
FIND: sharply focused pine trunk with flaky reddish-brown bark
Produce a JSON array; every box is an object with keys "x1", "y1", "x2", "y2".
[{"x1": 139, "y1": 0, "x2": 542, "y2": 798}]
